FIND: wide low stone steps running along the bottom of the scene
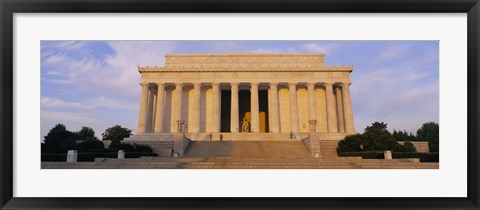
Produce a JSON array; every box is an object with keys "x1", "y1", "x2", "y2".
[{"x1": 41, "y1": 157, "x2": 439, "y2": 169}]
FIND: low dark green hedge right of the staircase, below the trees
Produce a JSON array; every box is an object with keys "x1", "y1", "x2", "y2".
[{"x1": 338, "y1": 151, "x2": 439, "y2": 162}]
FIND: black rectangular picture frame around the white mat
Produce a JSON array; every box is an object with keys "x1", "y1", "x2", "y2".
[{"x1": 0, "y1": 0, "x2": 480, "y2": 209}]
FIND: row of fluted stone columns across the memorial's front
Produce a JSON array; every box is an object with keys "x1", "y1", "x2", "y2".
[{"x1": 137, "y1": 83, "x2": 355, "y2": 133}]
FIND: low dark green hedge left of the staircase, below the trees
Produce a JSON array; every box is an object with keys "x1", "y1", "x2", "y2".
[{"x1": 42, "y1": 152, "x2": 158, "y2": 162}]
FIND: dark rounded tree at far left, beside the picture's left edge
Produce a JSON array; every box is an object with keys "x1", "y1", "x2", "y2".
[{"x1": 42, "y1": 123, "x2": 74, "y2": 153}]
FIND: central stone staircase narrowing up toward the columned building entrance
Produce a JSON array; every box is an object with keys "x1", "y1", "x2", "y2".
[{"x1": 184, "y1": 140, "x2": 310, "y2": 159}]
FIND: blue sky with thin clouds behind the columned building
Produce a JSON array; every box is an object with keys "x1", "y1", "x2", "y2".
[{"x1": 40, "y1": 41, "x2": 439, "y2": 139}]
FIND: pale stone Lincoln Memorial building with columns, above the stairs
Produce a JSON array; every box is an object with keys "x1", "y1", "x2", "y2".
[{"x1": 126, "y1": 53, "x2": 355, "y2": 158}]
